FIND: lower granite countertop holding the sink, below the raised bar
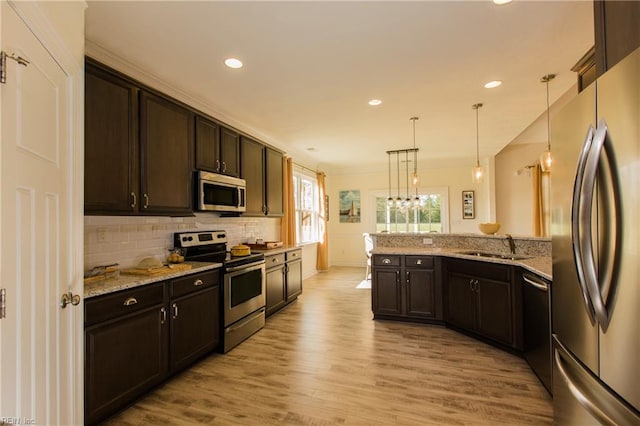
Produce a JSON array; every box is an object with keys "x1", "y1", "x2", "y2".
[{"x1": 373, "y1": 247, "x2": 552, "y2": 280}]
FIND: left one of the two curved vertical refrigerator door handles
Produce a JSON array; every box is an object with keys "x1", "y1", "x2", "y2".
[{"x1": 571, "y1": 126, "x2": 596, "y2": 324}]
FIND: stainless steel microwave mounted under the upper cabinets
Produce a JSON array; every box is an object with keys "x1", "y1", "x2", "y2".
[{"x1": 195, "y1": 171, "x2": 247, "y2": 213}]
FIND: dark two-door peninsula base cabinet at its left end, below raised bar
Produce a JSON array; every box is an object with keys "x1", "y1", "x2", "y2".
[{"x1": 372, "y1": 255, "x2": 442, "y2": 321}]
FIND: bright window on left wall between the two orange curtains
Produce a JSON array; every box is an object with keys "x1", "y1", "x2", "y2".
[{"x1": 293, "y1": 173, "x2": 320, "y2": 244}]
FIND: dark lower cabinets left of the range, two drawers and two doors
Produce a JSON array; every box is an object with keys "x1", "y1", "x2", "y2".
[{"x1": 85, "y1": 270, "x2": 220, "y2": 424}]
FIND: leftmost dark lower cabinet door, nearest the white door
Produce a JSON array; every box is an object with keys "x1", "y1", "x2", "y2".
[{"x1": 85, "y1": 305, "x2": 168, "y2": 424}]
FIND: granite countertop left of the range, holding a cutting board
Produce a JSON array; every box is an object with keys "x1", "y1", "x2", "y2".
[{"x1": 84, "y1": 262, "x2": 222, "y2": 299}]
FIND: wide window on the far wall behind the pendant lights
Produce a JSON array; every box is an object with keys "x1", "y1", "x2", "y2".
[{"x1": 375, "y1": 188, "x2": 449, "y2": 233}]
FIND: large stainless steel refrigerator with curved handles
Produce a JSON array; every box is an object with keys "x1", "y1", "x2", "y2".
[{"x1": 551, "y1": 49, "x2": 640, "y2": 426}]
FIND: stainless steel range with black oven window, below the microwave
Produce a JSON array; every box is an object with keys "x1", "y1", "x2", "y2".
[{"x1": 174, "y1": 231, "x2": 266, "y2": 353}]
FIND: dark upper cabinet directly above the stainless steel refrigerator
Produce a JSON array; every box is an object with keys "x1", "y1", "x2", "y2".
[{"x1": 593, "y1": 0, "x2": 640, "y2": 77}]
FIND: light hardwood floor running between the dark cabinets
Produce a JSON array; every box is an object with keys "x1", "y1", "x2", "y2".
[{"x1": 102, "y1": 268, "x2": 552, "y2": 425}]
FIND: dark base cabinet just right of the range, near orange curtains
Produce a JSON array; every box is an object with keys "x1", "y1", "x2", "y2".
[{"x1": 265, "y1": 249, "x2": 302, "y2": 316}]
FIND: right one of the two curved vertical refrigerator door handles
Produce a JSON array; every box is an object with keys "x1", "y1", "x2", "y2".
[{"x1": 579, "y1": 120, "x2": 610, "y2": 331}]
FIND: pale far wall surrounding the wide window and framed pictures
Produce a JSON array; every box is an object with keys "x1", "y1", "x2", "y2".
[{"x1": 326, "y1": 163, "x2": 495, "y2": 267}]
